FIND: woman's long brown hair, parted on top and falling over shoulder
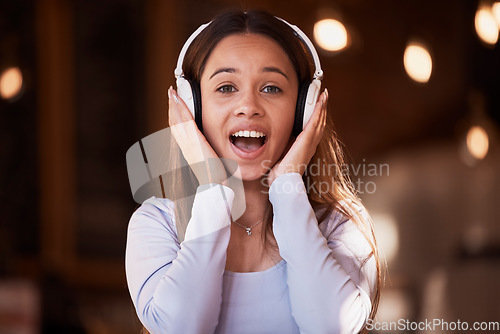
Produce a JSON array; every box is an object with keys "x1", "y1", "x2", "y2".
[{"x1": 176, "y1": 10, "x2": 381, "y2": 330}]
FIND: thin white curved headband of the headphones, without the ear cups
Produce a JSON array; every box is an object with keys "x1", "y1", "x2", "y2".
[{"x1": 174, "y1": 16, "x2": 323, "y2": 80}]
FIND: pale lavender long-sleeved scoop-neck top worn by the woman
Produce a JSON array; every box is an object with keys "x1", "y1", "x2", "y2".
[{"x1": 126, "y1": 173, "x2": 377, "y2": 334}]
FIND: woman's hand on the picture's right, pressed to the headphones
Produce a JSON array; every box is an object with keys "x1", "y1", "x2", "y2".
[{"x1": 267, "y1": 89, "x2": 328, "y2": 186}]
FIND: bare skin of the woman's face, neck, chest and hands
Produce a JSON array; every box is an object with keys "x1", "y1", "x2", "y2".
[{"x1": 168, "y1": 34, "x2": 328, "y2": 272}]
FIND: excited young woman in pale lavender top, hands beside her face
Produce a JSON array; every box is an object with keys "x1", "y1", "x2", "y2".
[{"x1": 126, "y1": 11, "x2": 380, "y2": 334}]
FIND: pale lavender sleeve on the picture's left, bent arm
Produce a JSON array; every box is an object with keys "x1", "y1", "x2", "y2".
[{"x1": 125, "y1": 185, "x2": 234, "y2": 334}]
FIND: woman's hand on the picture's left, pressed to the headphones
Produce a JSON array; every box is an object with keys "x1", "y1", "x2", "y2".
[{"x1": 168, "y1": 87, "x2": 227, "y2": 185}]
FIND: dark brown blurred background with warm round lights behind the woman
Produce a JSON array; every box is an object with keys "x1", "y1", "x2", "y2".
[{"x1": 0, "y1": 0, "x2": 500, "y2": 334}]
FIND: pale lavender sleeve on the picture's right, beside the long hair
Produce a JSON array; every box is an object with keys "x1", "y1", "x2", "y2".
[{"x1": 269, "y1": 173, "x2": 377, "y2": 334}]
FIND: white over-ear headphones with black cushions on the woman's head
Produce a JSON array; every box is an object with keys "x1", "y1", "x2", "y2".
[{"x1": 174, "y1": 17, "x2": 323, "y2": 136}]
